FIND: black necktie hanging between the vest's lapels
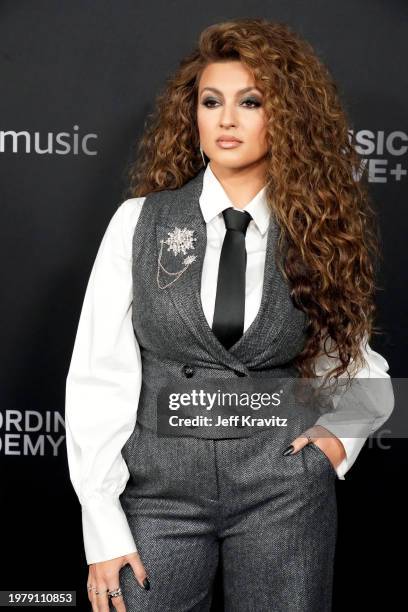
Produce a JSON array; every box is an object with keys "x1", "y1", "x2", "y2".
[{"x1": 212, "y1": 207, "x2": 252, "y2": 349}]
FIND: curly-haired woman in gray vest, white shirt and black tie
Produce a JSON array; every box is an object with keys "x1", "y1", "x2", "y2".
[{"x1": 66, "y1": 19, "x2": 393, "y2": 612}]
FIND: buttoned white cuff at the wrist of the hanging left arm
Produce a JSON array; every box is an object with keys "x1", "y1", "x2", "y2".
[{"x1": 82, "y1": 497, "x2": 137, "y2": 565}]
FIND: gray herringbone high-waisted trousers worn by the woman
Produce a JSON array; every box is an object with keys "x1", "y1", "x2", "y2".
[{"x1": 120, "y1": 423, "x2": 337, "y2": 612}]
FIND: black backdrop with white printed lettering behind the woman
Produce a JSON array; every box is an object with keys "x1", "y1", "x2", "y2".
[{"x1": 0, "y1": 0, "x2": 408, "y2": 610}]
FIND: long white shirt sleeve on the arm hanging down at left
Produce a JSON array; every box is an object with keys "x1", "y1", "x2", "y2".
[{"x1": 65, "y1": 198, "x2": 144, "y2": 564}]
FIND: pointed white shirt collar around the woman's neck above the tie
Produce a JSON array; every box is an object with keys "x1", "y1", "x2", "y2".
[{"x1": 199, "y1": 163, "x2": 271, "y2": 235}]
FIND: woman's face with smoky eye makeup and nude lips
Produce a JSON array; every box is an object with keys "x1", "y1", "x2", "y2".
[{"x1": 197, "y1": 61, "x2": 268, "y2": 169}]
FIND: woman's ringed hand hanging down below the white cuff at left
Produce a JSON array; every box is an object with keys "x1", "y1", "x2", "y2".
[{"x1": 88, "y1": 552, "x2": 150, "y2": 612}]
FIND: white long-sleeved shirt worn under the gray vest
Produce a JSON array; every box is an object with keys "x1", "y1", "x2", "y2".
[{"x1": 65, "y1": 164, "x2": 394, "y2": 563}]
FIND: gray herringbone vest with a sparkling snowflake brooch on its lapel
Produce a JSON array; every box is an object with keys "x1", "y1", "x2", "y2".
[{"x1": 132, "y1": 170, "x2": 306, "y2": 429}]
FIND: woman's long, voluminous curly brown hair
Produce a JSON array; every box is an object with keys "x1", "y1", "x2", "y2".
[{"x1": 123, "y1": 19, "x2": 380, "y2": 388}]
